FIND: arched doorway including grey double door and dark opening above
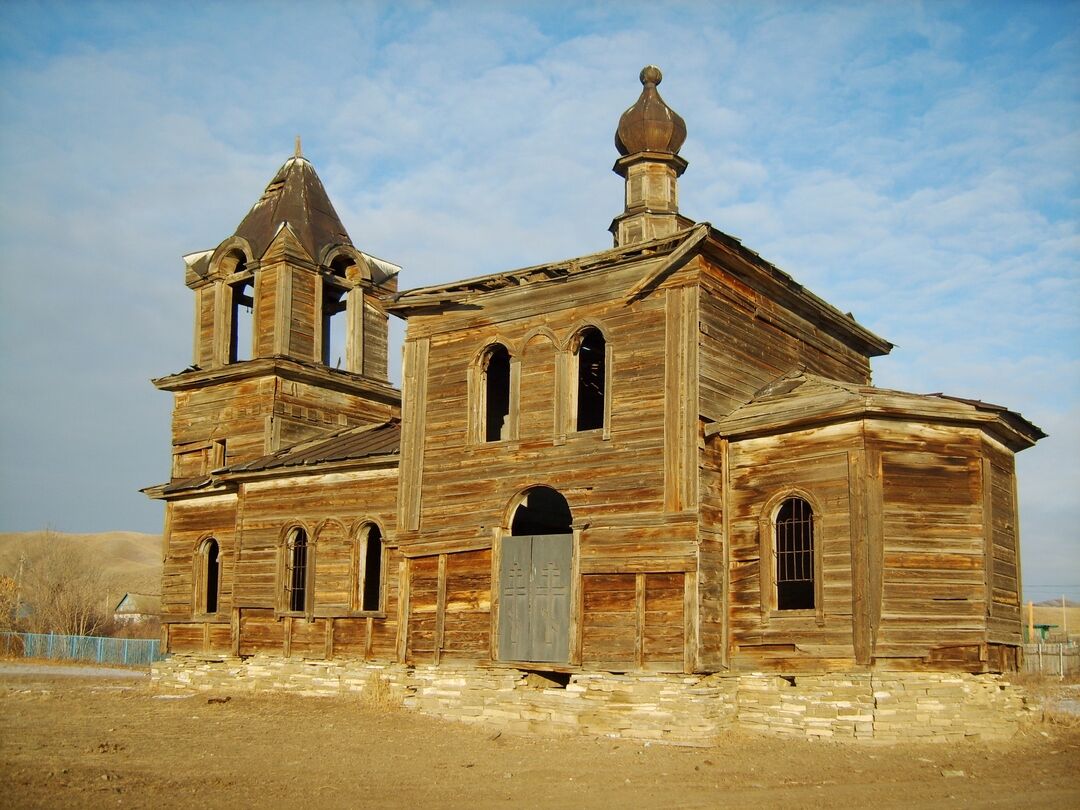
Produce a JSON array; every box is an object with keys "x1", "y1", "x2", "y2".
[{"x1": 499, "y1": 487, "x2": 573, "y2": 663}]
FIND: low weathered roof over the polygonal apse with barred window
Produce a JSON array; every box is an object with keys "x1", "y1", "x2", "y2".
[{"x1": 705, "y1": 369, "x2": 1047, "y2": 450}]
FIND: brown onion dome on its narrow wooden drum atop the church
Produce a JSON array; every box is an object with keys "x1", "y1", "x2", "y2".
[{"x1": 608, "y1": 65, "x2": 693, "y2": 247}]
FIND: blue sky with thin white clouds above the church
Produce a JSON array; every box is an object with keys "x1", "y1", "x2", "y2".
[{"x1": 0, "y1": 0, "x2": 1080, "y2": 598}]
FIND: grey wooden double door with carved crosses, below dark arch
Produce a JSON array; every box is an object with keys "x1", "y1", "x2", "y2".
[{"x1": 499, "y1": 535, "x2": 573, "y2": 663}]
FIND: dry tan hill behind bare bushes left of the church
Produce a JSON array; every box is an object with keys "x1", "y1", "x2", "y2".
[{"x1": 0, "y1": 530, "x2": 161, "y2": 602}]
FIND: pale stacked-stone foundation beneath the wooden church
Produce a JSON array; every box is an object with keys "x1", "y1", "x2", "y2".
[{"x1": 152, "y1": 656, "x2": 1028, "y2": 745}]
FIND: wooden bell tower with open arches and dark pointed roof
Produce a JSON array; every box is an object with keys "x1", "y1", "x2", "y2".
[{"x1": 153, "y1": 144, "x2": 401, "y2": 481}]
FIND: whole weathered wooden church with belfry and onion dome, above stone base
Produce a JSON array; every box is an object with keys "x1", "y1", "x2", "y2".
[{"x1": 146, "y1": 66, "x2": 1043, "y2": 673}]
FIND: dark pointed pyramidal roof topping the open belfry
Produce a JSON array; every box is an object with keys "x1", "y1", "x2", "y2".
[{"x1": 235, "y1": 138, "x2": 352, "y2": 261}]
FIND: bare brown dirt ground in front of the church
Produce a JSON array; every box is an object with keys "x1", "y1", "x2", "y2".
[{"x1": 0, "y1": 663, "x2": 1080, "y2": 810}]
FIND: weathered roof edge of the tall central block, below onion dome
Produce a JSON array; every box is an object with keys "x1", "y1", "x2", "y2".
[{"x1": 387, "y1": 222, "x2": 892, "y2": 357}]
